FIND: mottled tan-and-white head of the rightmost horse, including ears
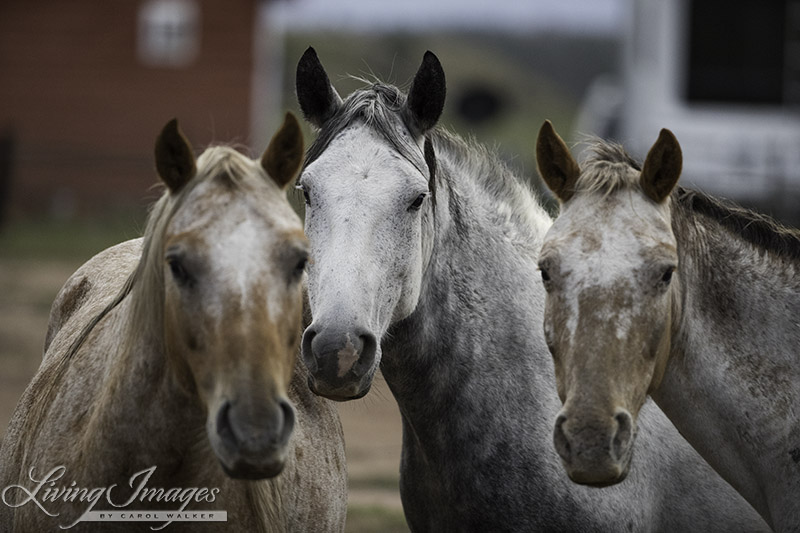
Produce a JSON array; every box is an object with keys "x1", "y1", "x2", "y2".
[{"x1": 536, "y1": 122, "x2": 681, "y2": 485}]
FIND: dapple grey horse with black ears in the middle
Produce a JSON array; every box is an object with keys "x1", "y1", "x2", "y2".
[{"x1": 297, "y1": 50, "x2": 767, "y2": 531}]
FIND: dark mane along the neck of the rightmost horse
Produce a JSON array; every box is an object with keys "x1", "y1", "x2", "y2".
[{"x1": 673, "y1": 188, "x2": 800, "y2": 261}]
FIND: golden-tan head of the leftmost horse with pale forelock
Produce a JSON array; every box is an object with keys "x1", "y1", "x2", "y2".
[{"x1": 154, "y1": 115, "x2": 308, "y2": 478}]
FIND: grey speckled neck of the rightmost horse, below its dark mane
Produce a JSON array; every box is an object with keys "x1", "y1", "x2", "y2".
[{"x1": 653, "y1": 209, "x2": 800, "y2": 525}]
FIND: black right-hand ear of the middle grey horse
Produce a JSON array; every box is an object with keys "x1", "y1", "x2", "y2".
[{"x1": 406, "y1": 52, "x2": 447, "y2": 135}]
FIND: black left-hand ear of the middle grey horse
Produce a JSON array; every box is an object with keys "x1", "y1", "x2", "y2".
[{"x1": 295, "y1": 46, "x2": 342, "y2": 128}]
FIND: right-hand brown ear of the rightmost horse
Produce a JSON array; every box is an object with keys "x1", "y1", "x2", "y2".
[{"x1": 640, "y1": 128, "x2": 683, "y2": 204}]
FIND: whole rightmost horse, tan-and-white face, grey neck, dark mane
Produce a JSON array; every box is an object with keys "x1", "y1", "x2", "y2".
[{"x1": 537, "y1": 118, "x2": 800, "y2": 531}]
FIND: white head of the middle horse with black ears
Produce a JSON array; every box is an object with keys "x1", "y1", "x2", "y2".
[{"x1": 296, "y1": 48, "x2": 445, "y2": 400}]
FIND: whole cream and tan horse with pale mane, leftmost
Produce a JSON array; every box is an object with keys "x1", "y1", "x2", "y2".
[{"x1": 0, "y1": 115, "x2": 346, "y2": 532}]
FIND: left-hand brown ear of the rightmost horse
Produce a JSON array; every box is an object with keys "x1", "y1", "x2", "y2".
[{"x1": 536, "y1": 120, "x2": 581, "y2": 203}]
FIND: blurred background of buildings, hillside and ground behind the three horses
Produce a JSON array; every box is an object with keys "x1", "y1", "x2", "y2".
[{"x1": 0, "y1": 0, "x2": 800, "y2": 531}]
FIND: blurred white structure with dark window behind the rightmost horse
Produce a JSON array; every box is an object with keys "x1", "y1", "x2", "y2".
[{"x1": 576, "y1": 0, "x2": 800, "y2": 223}]
